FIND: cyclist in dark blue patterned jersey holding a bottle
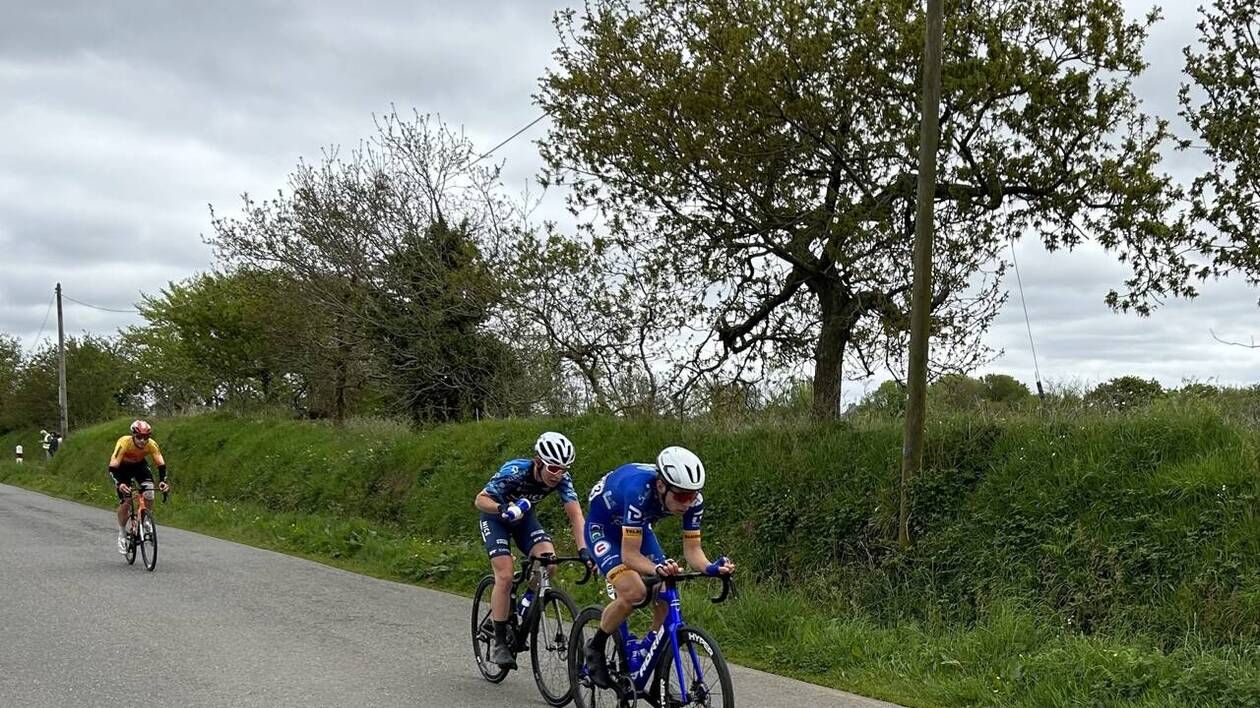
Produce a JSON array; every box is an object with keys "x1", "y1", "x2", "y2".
[{"x1": 474, "y1": 432, "x2": 593, "y2": 669}]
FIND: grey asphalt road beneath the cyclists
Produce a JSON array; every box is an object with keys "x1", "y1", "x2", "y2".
[{"x1": 0, "y1": 485, "x2": 907, "y2": 708}]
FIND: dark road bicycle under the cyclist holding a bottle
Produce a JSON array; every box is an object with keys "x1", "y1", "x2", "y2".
[{"x1": 473, "y1": 556, "x2": 591, "y2": 705}]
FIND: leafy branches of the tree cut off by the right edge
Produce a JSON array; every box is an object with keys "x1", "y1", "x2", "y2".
[{"x1": 1179, "y1": 0, "x2": 1260, "y2": 282}]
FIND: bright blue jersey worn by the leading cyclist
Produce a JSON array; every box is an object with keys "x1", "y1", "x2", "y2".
[{"x1": 587, "y1": 462, "x2": 704, "y2": 533}]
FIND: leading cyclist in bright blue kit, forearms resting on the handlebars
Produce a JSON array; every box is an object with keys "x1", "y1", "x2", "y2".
[{"x1": 586, "y1": 446, "x2": 735, "y2": 688}]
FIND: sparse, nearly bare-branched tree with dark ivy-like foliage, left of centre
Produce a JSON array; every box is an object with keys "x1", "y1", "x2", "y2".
[{"x1": 210, "y1": 108, "x2": 512, "y2": 420}]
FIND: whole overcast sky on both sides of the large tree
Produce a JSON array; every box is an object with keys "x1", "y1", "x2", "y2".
[{"x1": 0, "y1": 0, "x2": 1260, "y2": 398}]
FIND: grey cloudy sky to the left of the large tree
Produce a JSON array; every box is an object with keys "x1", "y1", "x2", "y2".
[{"x1": 0, "y1": 1, "x2": 577, "y2": 347}]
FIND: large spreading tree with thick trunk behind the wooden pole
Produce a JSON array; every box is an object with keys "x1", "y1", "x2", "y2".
[{"x1": 538, "y1": 0, "x2": 1197, "y2": 417}]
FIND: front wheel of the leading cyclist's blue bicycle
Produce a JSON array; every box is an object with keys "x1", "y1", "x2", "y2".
[{"x1": 653, "y1": 627, "x2": 735, "y2": 708}]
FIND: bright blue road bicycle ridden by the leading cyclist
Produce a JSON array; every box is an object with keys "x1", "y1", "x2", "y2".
[{"x1": 568, "y1": 572, "x2": 735, "y2": 708}]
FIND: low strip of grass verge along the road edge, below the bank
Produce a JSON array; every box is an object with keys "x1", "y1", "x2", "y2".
[{"x1": 0, "y1": 451, "x2": 1260, "y2": 707}]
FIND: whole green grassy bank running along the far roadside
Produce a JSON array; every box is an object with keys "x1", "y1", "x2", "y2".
[{"x1": 0, "y1": 409, "x2": 1260, "y2": 705}]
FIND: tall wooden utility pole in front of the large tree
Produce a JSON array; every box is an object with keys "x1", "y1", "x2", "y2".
[{"x1": 897, "y1": 0, "x2": 945, "y2": 548}]
